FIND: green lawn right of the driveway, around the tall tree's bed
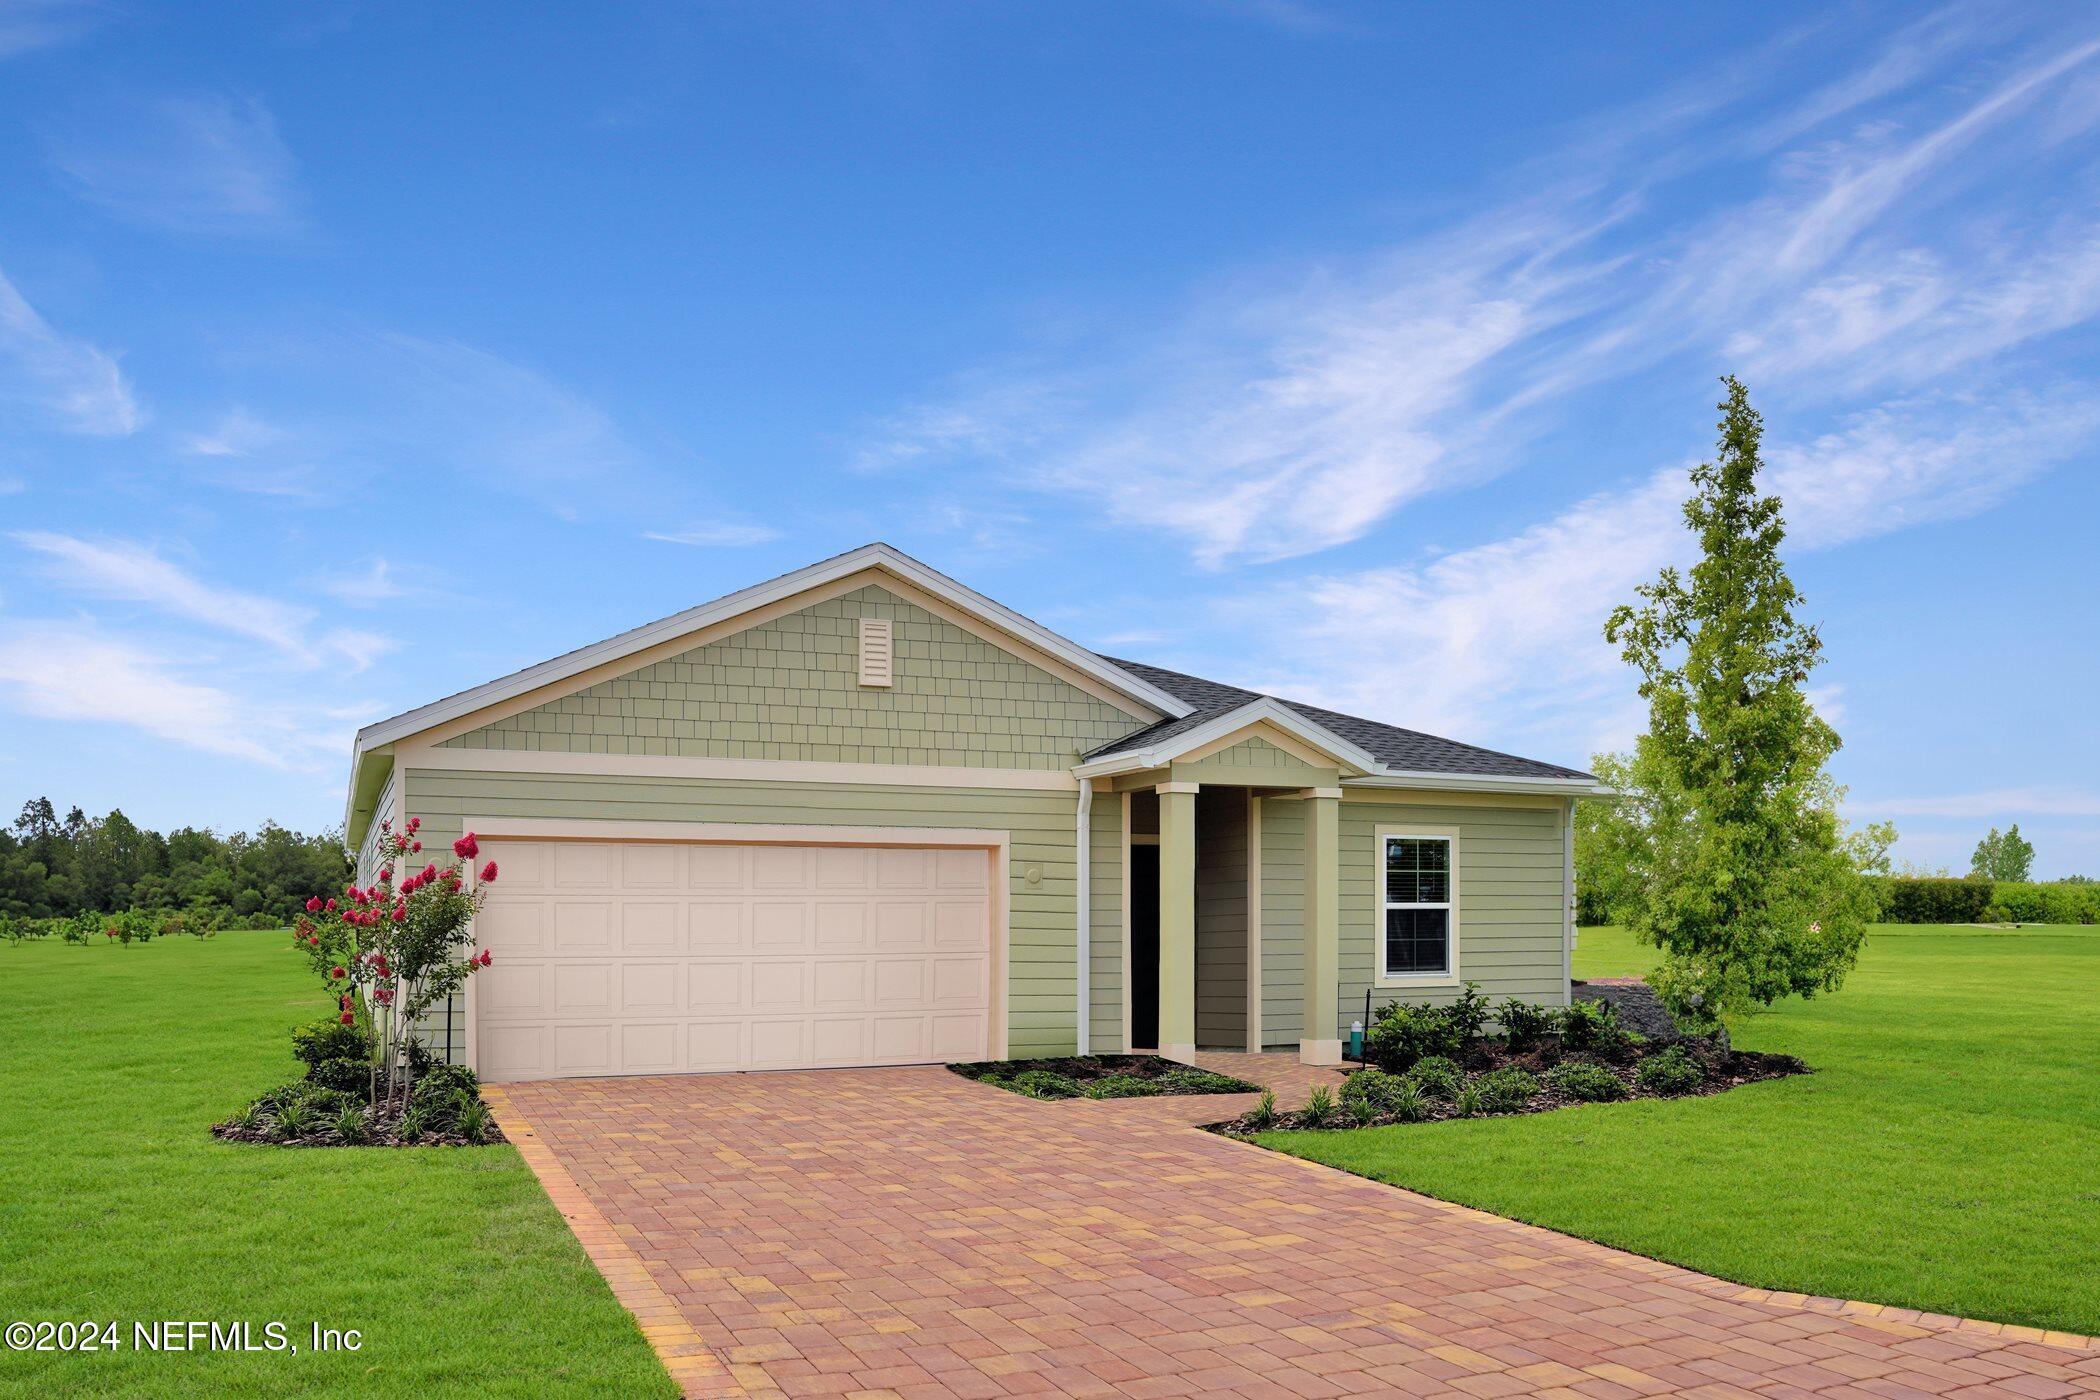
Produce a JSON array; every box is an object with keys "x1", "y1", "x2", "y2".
[{"x1": 1260, "y1": 926, "x2": 2100, "y2": 1333}]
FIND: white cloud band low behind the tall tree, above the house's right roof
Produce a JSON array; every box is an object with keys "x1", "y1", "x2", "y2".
[{"x1": 1233, "y1": 390, "x2": 2100, "y2": 751}]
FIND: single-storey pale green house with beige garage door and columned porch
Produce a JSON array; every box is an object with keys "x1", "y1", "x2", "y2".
[{"x1": 347, "y1": 544, "x2": 1596, "y2": 1081}]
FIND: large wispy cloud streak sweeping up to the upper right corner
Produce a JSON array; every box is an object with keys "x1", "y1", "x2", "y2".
[{"x1": 863, "y1": 15, "x2": 2100, "y2": 565}]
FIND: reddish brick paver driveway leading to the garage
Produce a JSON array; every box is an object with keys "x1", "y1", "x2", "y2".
[{"x1": 491, "y1": 1068, "x2": 2100, "y2": 1396}]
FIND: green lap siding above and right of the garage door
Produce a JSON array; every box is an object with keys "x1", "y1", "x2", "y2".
[{"x1": 405, "y1": 768, "x2": 1077, "y2": 1056}]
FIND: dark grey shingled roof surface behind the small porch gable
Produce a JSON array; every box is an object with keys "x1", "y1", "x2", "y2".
[{"x1": 1082, "y1": 661, "x2": 1596, "y2": 787}]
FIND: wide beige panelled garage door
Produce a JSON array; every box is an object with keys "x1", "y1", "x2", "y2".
[{"x1": 473, "y1": 840, "x2": 991, "y2": 1083}]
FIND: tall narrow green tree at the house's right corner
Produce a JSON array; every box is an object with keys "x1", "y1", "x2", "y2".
[{"x1": 1604, "y1": 376, "x2": 1886, "y2": 1024}]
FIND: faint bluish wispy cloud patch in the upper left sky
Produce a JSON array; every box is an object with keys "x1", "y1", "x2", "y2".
[{"x1": 44, "y1": 94, "x2": 307, "y2": 237}]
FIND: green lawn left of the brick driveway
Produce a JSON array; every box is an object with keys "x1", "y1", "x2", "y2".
[{"x1": 0, "y1": 932, "x2": 676, "y2": 1396}]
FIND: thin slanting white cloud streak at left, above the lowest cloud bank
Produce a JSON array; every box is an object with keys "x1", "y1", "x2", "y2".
[{"x1": 13, "y1": 531, "x2": 393, "y2": 670}]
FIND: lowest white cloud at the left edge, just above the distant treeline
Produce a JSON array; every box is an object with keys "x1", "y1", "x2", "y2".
[{"x1": 0, "y1": 621, "x2": 353, "y2": 770}]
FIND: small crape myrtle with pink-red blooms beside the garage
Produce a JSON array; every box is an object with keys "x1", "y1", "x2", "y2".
[{"x1": 292, "y1": 816, "x2": 496, "y2": 1108}]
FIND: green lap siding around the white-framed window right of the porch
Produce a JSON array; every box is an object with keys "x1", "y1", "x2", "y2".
[{"x1": 1340, "y1": 800, "x2": 1567, "y2": 1035}]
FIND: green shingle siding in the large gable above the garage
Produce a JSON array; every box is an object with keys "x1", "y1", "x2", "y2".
[{"x1": 443, "y1": 586, "x2": 1142, "y2": 770}]
